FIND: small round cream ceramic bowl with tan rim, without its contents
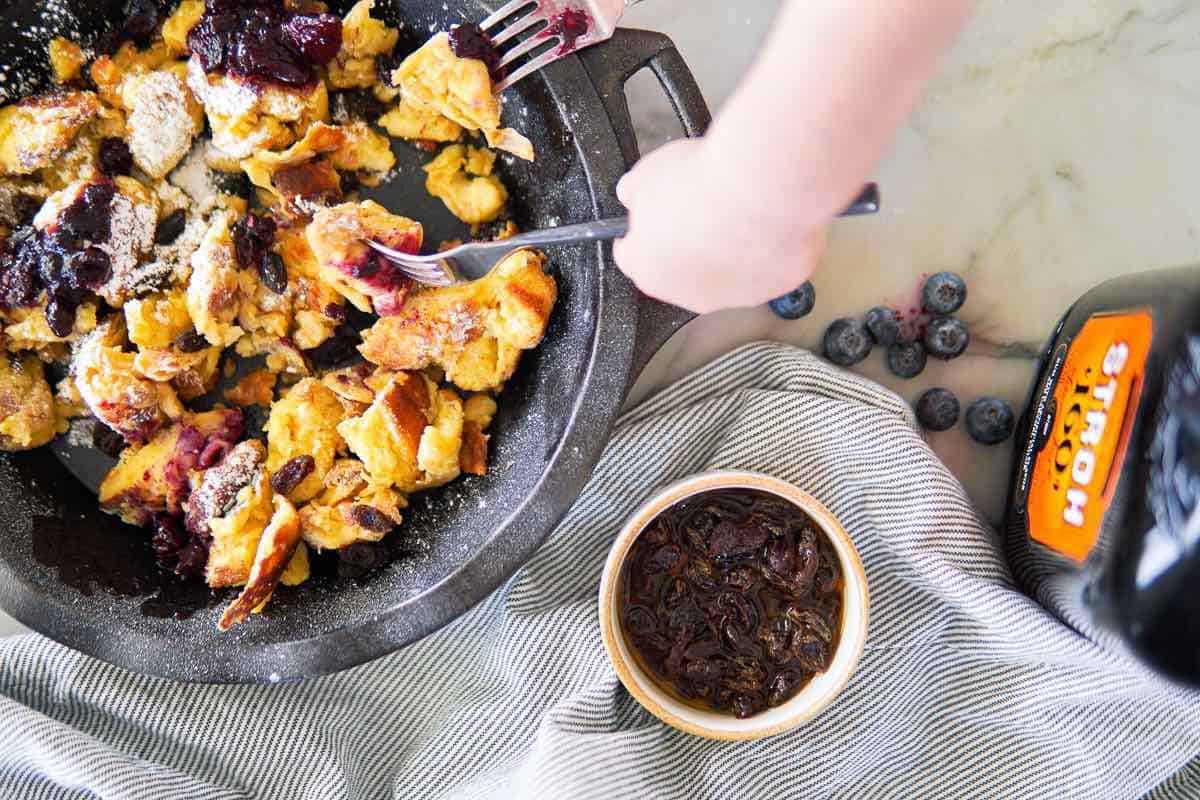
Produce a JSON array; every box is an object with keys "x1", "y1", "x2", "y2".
[{"x1": 600, "y1": 471, "x2": 870, "y2": 740}]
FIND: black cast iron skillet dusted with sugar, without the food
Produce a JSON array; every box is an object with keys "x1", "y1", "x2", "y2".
[{"x1": 0, "y1": 0, "x2": 709, "y2": 682}]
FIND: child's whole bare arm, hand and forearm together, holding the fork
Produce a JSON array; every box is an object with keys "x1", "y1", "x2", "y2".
[{"x1": 613, "y1": 0, "x2": 972, "y2": 313}]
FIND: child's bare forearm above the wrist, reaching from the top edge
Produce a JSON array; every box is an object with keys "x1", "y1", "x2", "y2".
[{"x1": 707, "y1": 0, "x2": 971, "y2": 228}]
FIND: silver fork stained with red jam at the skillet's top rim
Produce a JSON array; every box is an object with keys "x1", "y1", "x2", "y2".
[{"x1": 479, "y1": 0, "x2": 642, "y2": 94}]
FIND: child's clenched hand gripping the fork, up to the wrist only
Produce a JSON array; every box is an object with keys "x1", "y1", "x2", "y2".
[{"x1": 613, "y1": 139, "x2": 828, "y2": 314}]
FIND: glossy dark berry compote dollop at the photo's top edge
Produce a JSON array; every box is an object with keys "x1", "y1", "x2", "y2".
[{"x1": 187, "y1": 0, "x2": 342, "y2": 86}]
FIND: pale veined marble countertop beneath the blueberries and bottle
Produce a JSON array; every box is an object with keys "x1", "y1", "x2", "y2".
[{"x1": 0, "y1": 0, "x2": 1200, "y2": 636}]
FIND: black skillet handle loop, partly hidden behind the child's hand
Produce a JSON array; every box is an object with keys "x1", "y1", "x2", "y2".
[{"x1": 580, "y1": 28, "x2": 713, "y2": 384}]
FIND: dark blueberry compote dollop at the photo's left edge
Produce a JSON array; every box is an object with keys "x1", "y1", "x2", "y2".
[{"x1": 0, "y1": 181, "x2": 115, "y2": 337}]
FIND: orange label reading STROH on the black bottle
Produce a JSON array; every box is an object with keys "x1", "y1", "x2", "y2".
[{"x1": 1026, "y1": 311, "x2": 1154, "y2": 561}]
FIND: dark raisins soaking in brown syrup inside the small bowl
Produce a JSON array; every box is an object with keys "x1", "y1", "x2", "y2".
[{"x1": 617, "y1": 489, "x2": 845, "y2": 718}]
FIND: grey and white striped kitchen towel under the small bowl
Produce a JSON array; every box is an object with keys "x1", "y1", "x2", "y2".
[{"x1": 0, "y1": 343, "x2": 1200, "y2": 800}]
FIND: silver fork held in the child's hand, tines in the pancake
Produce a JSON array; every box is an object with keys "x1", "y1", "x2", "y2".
[{"x1": 366, "y1": 184, "x2": 880, "y2": 287}]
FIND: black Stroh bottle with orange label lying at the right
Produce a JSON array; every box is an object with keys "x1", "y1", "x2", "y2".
[{"x1": 1006, "y1": 265, "x2": 1200, "y2": 686}]
